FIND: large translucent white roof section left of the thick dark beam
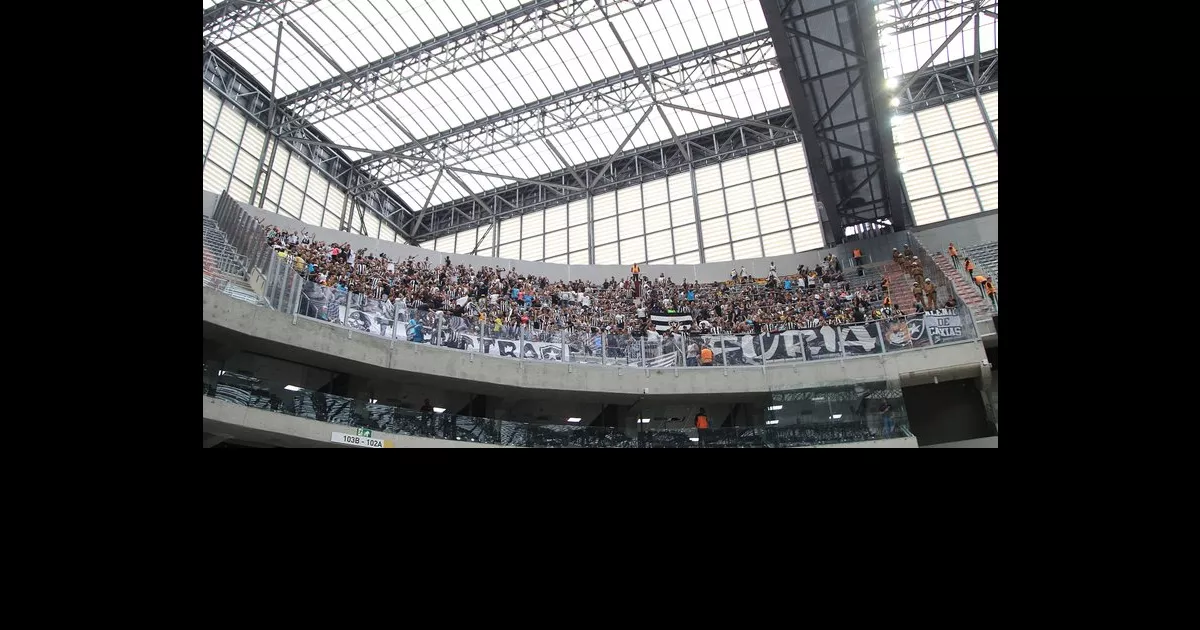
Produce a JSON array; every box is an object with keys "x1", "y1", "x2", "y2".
[{"x1": 205, "y1": 0, "x2": 787, "y2": 206}]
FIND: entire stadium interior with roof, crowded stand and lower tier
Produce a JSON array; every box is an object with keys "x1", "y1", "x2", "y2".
[{"x1": 202, "y1": 0, "x2": 1000, "y2": 449}]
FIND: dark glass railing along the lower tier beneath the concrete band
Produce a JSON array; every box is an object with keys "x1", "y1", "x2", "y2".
[{"x1": 203, "y1": 368, "x2": 911, "y2": 449}]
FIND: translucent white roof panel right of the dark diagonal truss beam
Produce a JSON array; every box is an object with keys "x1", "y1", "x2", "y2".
[{"x1": 875, "y1": 0, "x2": 1000, "y2": 77}]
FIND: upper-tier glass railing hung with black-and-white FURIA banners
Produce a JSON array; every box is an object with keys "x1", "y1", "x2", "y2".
[{"x1": 206, "y1": 194, "x2": 977, "y2": 368}]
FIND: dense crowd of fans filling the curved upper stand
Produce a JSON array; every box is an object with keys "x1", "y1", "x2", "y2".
[{"x1": 265, "y1": 226, "x2": 954, "y2": 337}]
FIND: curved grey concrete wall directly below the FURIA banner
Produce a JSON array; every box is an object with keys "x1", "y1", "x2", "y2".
[{"x1": 203, "y1": 289, "x2": 986, "y2": 396}]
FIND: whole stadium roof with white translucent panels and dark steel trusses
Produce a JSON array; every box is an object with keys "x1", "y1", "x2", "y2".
[{"x1": 204, "y1": 0, "x2": 998, "y2": 243}]
